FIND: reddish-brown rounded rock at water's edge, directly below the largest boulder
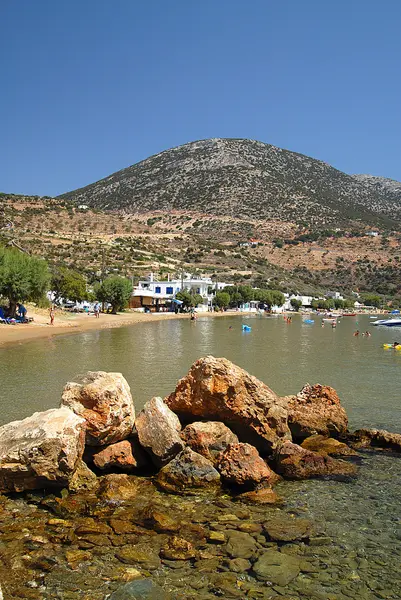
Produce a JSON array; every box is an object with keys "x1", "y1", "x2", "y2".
[{"x1": 216, "y1": 443, "x2": 279, "y2": 489}]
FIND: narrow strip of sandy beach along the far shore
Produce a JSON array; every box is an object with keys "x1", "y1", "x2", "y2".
[{"x1": 0, "y1": 307, "x2": 238, "y2": 349}]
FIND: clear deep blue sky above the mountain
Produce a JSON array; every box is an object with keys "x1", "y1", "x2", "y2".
[{"x1": 0, "y1": 0, "x2": 401, "y2": 195}]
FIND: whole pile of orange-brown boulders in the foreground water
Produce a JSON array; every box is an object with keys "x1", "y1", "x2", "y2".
[{"x1": 0, "y1": 356, "x2": 401, "y2": 496}]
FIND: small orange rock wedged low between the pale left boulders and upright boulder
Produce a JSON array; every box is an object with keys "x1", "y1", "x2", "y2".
[{"x1": 93, "y1": 440, "x2": 146, "y2": 471}]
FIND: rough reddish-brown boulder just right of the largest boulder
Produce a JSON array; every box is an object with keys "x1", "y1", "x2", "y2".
[{"x1": 285, "y1": 383, "x2": 348, "y2": 441}]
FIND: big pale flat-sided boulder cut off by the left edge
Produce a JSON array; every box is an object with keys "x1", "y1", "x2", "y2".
[{"x1": 0, "y1": 408, "x2": 85, "y2": 492}]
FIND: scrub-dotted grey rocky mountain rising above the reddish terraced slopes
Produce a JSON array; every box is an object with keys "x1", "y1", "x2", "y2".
[{"x1": 61, "y1": 139, "x2": 401, "y2": 228}]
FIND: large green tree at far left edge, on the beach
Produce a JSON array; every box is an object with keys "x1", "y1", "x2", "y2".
[{"x1": 0, "y1": 248, "x2": 50, "y2": 317}]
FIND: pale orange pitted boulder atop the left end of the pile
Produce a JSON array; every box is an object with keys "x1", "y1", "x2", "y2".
[{"x1": 61, "y1": 371, "x2": 135, "y2": 446}]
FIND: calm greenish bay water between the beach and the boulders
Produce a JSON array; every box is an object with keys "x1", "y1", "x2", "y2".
[{"x1": 0, "y1": 315, "x2": 401, "y2": 431}]
